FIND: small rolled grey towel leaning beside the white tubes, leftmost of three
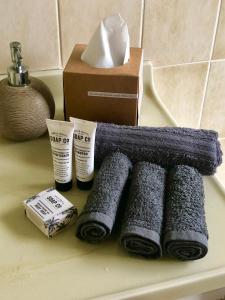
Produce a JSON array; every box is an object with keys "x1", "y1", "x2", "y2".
[{"x1": 76, "y1": 152, "x2": 132, "y2": 243}]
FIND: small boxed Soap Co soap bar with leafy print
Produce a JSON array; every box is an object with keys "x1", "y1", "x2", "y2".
[{"x1": 24, "y1": 188, "x2": 77, "y2": 237}]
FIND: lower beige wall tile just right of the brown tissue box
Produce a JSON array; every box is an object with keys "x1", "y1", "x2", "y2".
[{"x1": 154, "y1": 63, "x2": 209, "y2": 128}]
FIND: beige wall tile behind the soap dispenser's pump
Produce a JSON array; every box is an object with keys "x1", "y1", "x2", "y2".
[{"x1": 0, "y1": 0, "x2": 60, "y2": 73}]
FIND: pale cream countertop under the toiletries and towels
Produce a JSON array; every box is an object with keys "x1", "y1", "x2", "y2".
[{"x1": 0, "y1": 65, "x2": 225, "y2": 300}]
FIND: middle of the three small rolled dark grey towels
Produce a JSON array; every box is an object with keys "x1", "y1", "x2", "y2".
[{"x1": 120, "y1": 162, "x2": 165, "y2": 258}]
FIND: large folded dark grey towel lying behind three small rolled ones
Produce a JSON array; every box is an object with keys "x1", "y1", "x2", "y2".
[{"x1": 95, "y1": 123, "x2": 222, "y2": 175}]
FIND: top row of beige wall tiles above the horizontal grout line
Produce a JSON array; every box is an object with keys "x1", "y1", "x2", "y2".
[{"x1": 0, "y1": 0, "x2": 225, "y2": 73}]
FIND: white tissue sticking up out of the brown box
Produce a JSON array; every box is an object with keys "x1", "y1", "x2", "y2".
[{"x1": 81, "y1": 14, "x2": 130, "y2": 68}]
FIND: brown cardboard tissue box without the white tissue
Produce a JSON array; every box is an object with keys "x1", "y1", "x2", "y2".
[{"x1": 63, "y1": 44, "x2": 143, "y2": 125}]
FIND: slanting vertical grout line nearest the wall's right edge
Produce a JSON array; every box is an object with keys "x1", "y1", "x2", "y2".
[{"x1": 197, "y1": 0, "x2": 222, "y2": 128}]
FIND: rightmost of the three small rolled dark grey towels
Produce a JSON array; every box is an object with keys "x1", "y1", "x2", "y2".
[{"x1": 163, "y1": 165, "x2": 208, "y2": 260}]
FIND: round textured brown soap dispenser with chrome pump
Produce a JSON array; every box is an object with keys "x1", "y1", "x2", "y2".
[{"x1": 0, "y1": 42, "x2": 55, "y2": 141}]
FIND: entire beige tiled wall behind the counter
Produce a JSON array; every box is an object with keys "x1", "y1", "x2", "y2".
[{"x1": 0, "y1": 0, "x2": 225, "y2": 138}]
